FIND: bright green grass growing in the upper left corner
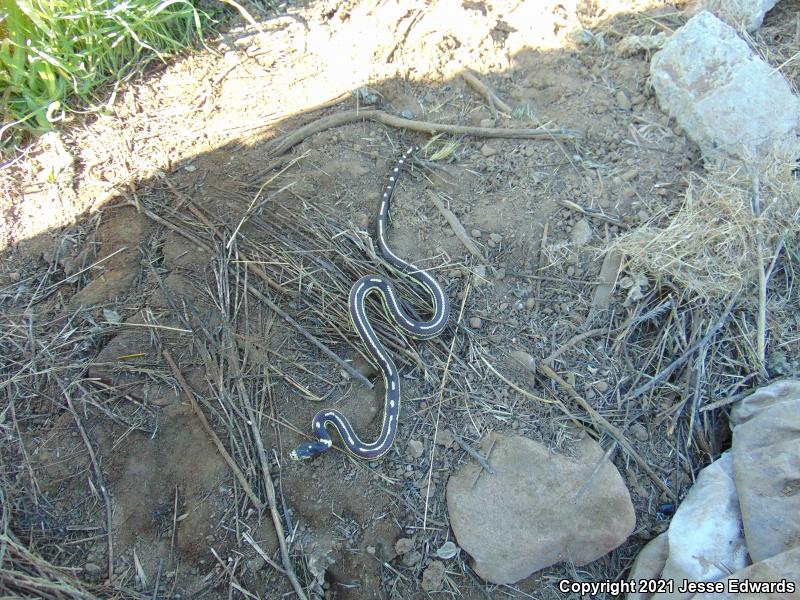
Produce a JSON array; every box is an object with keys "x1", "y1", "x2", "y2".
[{"x1": 0, "y1": 0, "x2": 205, "y2": 145}]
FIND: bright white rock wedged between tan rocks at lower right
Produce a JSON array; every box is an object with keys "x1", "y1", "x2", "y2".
[{"x1": 652, "y1": 452, "x2": 747, "y2": 600}]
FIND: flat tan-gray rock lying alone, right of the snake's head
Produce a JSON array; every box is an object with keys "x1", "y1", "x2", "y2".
[{"x1": 447, "y1": 433, "x2": 636, "y2": 584}]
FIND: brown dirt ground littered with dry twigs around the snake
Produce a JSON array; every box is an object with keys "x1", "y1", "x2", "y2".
[{"x1": 0, "y1": 0, "x2": 800, "y2": 598}]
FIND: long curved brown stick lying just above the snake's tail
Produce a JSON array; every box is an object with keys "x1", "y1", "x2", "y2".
[{"x1": 269, "y1": 109, "x2": 583, "y2": 156}]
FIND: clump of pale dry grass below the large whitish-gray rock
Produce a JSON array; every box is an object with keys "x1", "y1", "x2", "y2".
[{"x1": 614, "y1": 161, "x2": 800, "y2": 302}]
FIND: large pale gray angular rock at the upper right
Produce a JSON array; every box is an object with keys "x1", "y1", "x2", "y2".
[{"x1": 650, "y1": 11, "x2": 800, "y2": 161}]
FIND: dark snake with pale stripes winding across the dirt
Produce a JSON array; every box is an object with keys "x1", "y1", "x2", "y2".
[{"x1": 289, "y1": 147, "x2": 450, "y2": 460}]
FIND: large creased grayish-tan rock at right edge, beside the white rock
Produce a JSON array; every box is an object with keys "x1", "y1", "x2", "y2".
[{"x1": 731, "y1": 380, "x2": 800, "y2": 562}]
